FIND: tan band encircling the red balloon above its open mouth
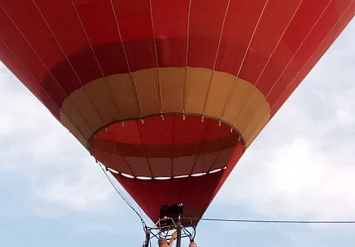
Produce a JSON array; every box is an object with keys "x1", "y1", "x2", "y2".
[{"x1": 61, "y1": 67, "x2": 270, "y2": 149}]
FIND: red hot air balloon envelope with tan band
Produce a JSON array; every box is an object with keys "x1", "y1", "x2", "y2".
[{"x1": 0, "y1": 0, "x2": 355, "y2": 245}]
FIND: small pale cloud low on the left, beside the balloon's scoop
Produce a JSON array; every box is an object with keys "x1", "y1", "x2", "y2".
[{"x1": 33, "y1": 164, "x2": 116, "y2": 211}]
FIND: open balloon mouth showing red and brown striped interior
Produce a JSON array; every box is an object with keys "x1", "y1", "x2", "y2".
[{"x1": 90, "y1": 114, "x2": 244, "y2": 180}]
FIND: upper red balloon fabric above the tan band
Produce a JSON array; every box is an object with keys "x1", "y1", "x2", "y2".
[{"x1": 0, "y1": 0, "x2": 355, "y2": 117}]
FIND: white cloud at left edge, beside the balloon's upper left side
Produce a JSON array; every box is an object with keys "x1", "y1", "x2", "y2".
[{"x1": 0, "y1": 68, "x2": 70, "y2": 171}]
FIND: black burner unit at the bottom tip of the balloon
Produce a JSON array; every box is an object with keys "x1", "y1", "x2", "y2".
[{"x1": 159, "y1": 203, "x2": 184, "y2": 226}]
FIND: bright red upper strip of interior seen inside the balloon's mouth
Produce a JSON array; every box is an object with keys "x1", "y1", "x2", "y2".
[{"x1": 96, "y1": 115, "x2": 235, "y2": 145}]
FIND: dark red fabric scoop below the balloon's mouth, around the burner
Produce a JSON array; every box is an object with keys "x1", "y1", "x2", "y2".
[{"x1": 114, "y1": 139, "x2": 244, "y2": 225}]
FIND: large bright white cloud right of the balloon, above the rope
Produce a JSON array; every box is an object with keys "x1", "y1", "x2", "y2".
[{"x1": 227, "y1": 136, "x2": 355, "y2": 219}]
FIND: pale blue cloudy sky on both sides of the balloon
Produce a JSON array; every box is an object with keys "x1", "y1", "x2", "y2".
[{"x1": 0, "y1": 18, "x2": 355, "y2": 247}]
